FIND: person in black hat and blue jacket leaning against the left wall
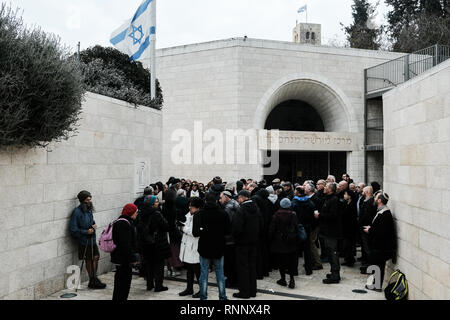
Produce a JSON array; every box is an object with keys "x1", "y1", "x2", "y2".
[{"x1": 69, "y1": 191, "x2": 106, "y2": 289}]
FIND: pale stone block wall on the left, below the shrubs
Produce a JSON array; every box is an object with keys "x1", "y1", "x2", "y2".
[{"x1": 0, "y1": 93, "x2": 162, "y2": 299}]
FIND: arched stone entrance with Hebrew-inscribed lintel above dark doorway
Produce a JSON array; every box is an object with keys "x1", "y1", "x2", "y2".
[{"x1": 254, "y1": 74, "x2": 360, "y2": 182}]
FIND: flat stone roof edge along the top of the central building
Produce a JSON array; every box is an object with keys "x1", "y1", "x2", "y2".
[{"x1": 156, "y1": 38, "x2": 405, "y2": 60}]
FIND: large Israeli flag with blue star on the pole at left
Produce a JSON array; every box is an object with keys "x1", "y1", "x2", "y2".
[{"x1": 110, "y1": 0, "x2": 156, "y2": 61}]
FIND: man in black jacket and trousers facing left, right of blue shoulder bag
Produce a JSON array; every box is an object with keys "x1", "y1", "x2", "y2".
[{"x1": 314, "y1": 182, "x2": 343, "y2": 284}]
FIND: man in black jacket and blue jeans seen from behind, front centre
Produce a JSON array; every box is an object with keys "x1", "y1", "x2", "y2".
[{"x1": 192, "y1": 193, "x2": 231, "y2": 300}]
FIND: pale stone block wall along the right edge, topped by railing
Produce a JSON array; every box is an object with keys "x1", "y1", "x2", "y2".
[{"x1": 383, "y1": 60, "x2": 450, "y2": 300}]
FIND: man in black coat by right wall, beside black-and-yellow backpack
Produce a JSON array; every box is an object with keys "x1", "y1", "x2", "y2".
[{"x1": 364, "y1": 190, "x2": 397, "y2": 292}]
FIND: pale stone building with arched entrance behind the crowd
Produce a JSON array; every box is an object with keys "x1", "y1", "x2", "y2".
[{"x1": 157, "y1": 38, "x2": 400, "y2": 182}]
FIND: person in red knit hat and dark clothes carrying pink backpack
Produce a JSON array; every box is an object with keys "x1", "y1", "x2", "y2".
[{"x1": 111, "y1": 203, "x2": 138, "y2": 301}]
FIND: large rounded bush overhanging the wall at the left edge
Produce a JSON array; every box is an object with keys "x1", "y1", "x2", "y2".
[{"x1": 0, "y1": 4, "x2": 84, "y2": 147}]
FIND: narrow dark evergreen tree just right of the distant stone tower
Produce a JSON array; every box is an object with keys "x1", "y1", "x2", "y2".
[{"x1": 344, "y1": 0, "x2": 381, "y2": 50}]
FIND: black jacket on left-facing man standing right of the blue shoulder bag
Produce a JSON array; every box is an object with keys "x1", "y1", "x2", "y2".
[{"x1": 319, "y1": 194, "x2": 343, "y2": 239}]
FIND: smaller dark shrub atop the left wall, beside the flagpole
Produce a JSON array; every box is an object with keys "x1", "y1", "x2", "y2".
[{"x1": 80, "y1": 46, "x2": 163, "y2": 110}]
